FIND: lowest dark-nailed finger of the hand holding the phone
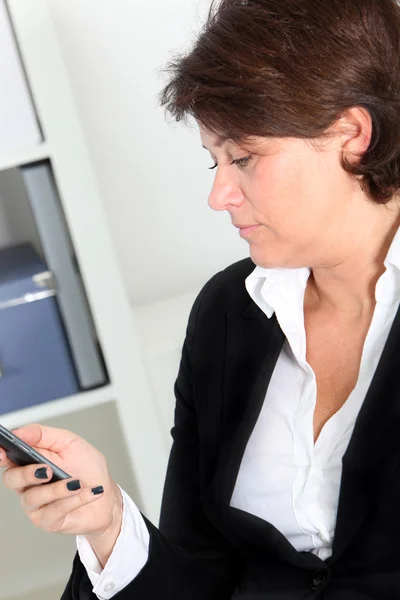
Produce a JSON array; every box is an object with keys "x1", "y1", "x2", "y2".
[{"x1": 30, "y1": 488, "x2": 107, "y2": 533}]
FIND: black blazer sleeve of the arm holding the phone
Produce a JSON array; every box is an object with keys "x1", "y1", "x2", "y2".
[{"x1": 61, "y1": 273, "x2": 241, "y2": 600}]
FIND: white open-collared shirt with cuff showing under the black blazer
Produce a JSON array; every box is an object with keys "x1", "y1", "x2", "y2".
[{"x1": 77, "y1": 224, "x2": 400, "y2": 600}]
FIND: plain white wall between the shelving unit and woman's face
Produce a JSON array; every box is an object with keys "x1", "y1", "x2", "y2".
[{"x1": 48, "y1": 0, "x2": 249, "y2": 304}]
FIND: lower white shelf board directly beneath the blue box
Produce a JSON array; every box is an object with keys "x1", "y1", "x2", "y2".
[{"x1": 0, "y1": 385, "x2": 115, "y2": 429}]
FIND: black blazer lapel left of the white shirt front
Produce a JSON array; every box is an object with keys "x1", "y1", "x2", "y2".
[{"x1": 205, "y1": 300, "x2": 320, "y2": 568}]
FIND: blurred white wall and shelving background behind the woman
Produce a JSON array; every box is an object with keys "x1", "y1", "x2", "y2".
[{"x1": 0, "y1": 0, "x2": 249, "y2": 600}]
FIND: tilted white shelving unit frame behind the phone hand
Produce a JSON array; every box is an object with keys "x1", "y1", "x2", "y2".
[{"x1": 0, "y1": 0, "x2": 167, "y2": 599}]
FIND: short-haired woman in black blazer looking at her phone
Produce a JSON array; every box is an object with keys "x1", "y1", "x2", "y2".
[{"x1": 1, "y1": 0, "x2": 400, "y2": 600}]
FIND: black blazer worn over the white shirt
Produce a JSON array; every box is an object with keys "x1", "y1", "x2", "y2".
[{"x1": 62, "y1": 259, "x2": 400, "y2": 600}]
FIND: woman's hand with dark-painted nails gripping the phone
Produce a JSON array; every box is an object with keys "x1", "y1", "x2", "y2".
[{"x1": 0, "y1": 424, "x2": 123, "y2": 566}]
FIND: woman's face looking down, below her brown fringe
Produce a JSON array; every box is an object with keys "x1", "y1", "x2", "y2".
[{"x1": 200, "y1": 126, "x2": 374, "y2": 268}]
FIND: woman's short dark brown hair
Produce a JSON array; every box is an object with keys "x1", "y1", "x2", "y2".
[{"x1": 160, "y1": 0, "x2": 400, "y2": 204}]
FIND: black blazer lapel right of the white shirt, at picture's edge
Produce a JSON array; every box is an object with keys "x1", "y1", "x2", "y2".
[{"x1": 327, "y1": 307, "x2": 400, "y2": 564}]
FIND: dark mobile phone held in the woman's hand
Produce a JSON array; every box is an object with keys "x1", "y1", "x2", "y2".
[{"x1": 0, "y1": 425, "x2": 71, "y2": 483}]
